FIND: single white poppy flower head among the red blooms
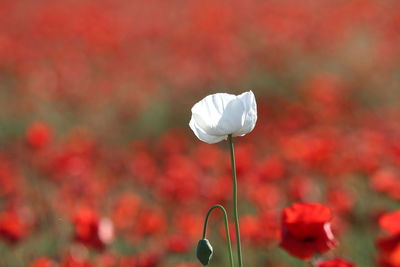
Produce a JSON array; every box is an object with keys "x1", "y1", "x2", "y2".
[{"x1": 189, "y1": 91, "x2": 257, "y2": 144}]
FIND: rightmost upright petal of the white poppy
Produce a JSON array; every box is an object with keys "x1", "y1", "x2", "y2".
[{"x1": 233, "y1": 91, "x2": 257, "y2": 136}]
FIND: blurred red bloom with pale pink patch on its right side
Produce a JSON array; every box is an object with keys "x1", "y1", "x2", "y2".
[{"x1": 73, "y1": 208, "x2": 113, "y2": 249}]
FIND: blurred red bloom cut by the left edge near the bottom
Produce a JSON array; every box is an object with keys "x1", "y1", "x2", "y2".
[{"x1": 0, "y1": 211, "x2": 28, "y2": 243}]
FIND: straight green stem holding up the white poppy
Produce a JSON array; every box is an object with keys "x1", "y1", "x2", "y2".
[{"x1": 228, "y1": 134, "x2": 243, "y2": 267}]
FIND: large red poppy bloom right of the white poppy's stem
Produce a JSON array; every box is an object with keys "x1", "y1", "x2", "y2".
[{"x1": 280, "y1": 203, "x2": 337, "y2": 260}]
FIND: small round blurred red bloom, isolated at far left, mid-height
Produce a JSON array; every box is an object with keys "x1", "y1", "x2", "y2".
[{"x1": 26, "y1": 122, "x2": 53, "y2": 149}]
